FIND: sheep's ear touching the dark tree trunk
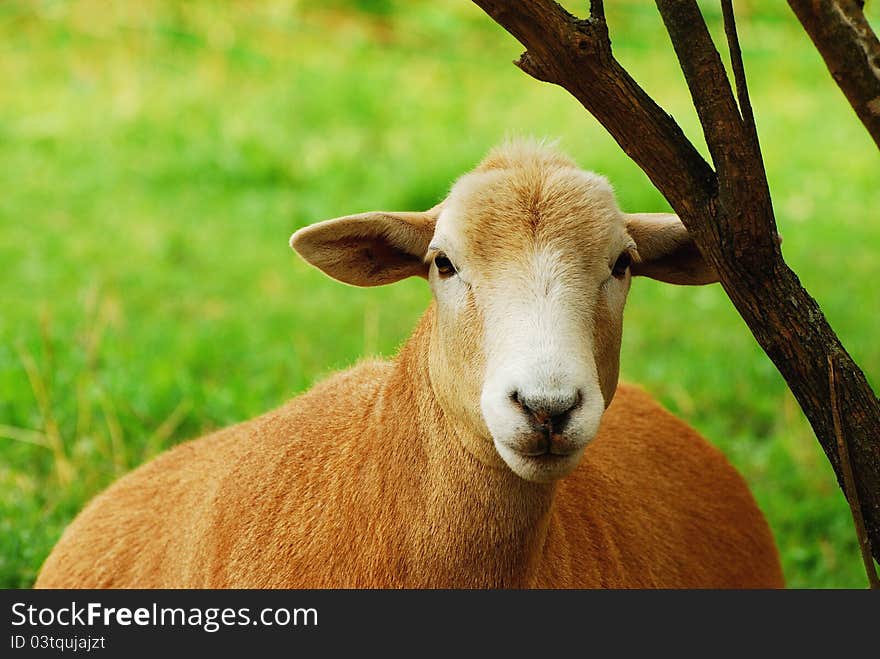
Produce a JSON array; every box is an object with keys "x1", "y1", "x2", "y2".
[{"x1": 626, "y1": 213, "x2": 718, "y2": 285}]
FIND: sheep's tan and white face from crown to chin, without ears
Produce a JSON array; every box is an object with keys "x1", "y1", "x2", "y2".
[{"x1": 428, "y1": 164, "x2": 636, "y2": 481}]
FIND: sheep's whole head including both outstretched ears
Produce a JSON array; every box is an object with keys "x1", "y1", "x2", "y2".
[{"x1": 291, "y1": 143, "x2": 716, "y2": 481}]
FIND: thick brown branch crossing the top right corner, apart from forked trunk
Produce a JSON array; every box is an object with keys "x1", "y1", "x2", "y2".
[{"x1": 788, "y1": 0, "x2": 880, "y2": 149}]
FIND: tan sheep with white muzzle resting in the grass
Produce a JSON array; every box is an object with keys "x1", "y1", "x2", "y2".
[{"x1": 36, "y1": 141, "x2": 783, "y2": 588}]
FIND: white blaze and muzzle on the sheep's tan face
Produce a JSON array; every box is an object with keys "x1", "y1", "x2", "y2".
[{"x1": 480, "y1": 248, "x2": 605, "y2": 481}]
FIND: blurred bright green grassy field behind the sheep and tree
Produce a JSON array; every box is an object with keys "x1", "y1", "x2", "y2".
[{"x1": 0, "y1": 0, "x2": 880, "y2": 587}]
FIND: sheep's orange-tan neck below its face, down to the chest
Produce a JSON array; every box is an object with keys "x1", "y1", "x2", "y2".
[{"x1": 384, "y1": 311, "x2": 558, "y2": 587}]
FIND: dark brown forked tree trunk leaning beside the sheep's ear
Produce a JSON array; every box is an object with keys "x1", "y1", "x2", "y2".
[{"x1": 474, "y1": 0, "x2": 880, "y2": 559}]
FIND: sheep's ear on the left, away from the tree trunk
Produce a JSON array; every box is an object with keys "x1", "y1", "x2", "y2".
[{"x1": 290, "y1": 207, "x2": 439, "y2": 286}]
